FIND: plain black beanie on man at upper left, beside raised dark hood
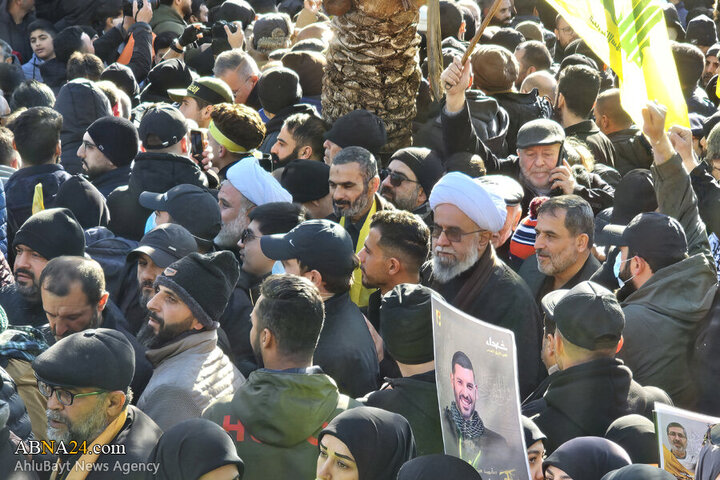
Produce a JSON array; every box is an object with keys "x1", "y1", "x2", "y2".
[{"x1": 88, "y1": 117, "x2": 140, "y2": 167}]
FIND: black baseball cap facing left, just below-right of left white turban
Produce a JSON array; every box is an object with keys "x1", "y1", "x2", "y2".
[{"x1": 260, "y1": 220, "x2": 356, "y2": 275}]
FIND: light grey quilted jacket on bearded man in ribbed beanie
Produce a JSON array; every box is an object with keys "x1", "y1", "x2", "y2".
[{"x1": 137, "y1": 330, "x2": 245, "y2": 430}]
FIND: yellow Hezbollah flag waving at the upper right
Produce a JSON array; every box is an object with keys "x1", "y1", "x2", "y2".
[{"x1": 546, "y1": 0, "x2": 690, "y2": 128}]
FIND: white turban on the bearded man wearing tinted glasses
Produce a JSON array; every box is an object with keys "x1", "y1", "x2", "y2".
[{"x1": 430, "y1": 172, "x2": 507, "y2": 233}]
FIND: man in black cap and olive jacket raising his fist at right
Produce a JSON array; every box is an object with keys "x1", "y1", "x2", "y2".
[{"x1": 603, "y1": 102, "x2": 717, "y2": 409}]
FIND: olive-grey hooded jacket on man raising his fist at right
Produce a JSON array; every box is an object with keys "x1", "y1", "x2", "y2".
[{"x1": 618, "y1": 155, "x2": 717, "y2": 409}]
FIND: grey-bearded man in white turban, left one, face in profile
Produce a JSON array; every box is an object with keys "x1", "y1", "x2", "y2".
[{"x1": 215, "y1": 157, "x2": 292, "y2": 250}]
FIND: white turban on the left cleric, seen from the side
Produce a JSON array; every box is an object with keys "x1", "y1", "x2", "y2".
[{"x1": 226, "y1": 157, "x2": 292, "y2": 206}]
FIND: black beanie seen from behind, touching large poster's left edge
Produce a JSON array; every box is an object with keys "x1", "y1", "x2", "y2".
[{"x1": 380, "y1": 283, "x2": 435, "y2": 365}]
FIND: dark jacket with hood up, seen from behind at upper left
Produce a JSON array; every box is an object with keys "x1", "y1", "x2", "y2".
[{"x1": 54, "y1": 78, "x2": 112, "y2": 175}]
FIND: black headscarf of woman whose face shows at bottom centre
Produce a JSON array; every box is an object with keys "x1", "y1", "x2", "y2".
[{"x1": 318, "y1": 407, "x2": 415, "y2": 480}]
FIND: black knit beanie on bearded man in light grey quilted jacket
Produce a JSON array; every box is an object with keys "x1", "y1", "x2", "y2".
[{"x1": 155, "y1": 250, "x2": 240, "y2": 329}]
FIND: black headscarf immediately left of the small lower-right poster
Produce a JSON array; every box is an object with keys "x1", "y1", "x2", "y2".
[{"x1": 605, "y1": 414, "x2": 660, "y2": 464}]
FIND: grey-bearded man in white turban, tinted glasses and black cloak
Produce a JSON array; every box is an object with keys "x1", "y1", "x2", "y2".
[{"x1": 423, "y1": 172, "x2": 541, "y2": 395}]
